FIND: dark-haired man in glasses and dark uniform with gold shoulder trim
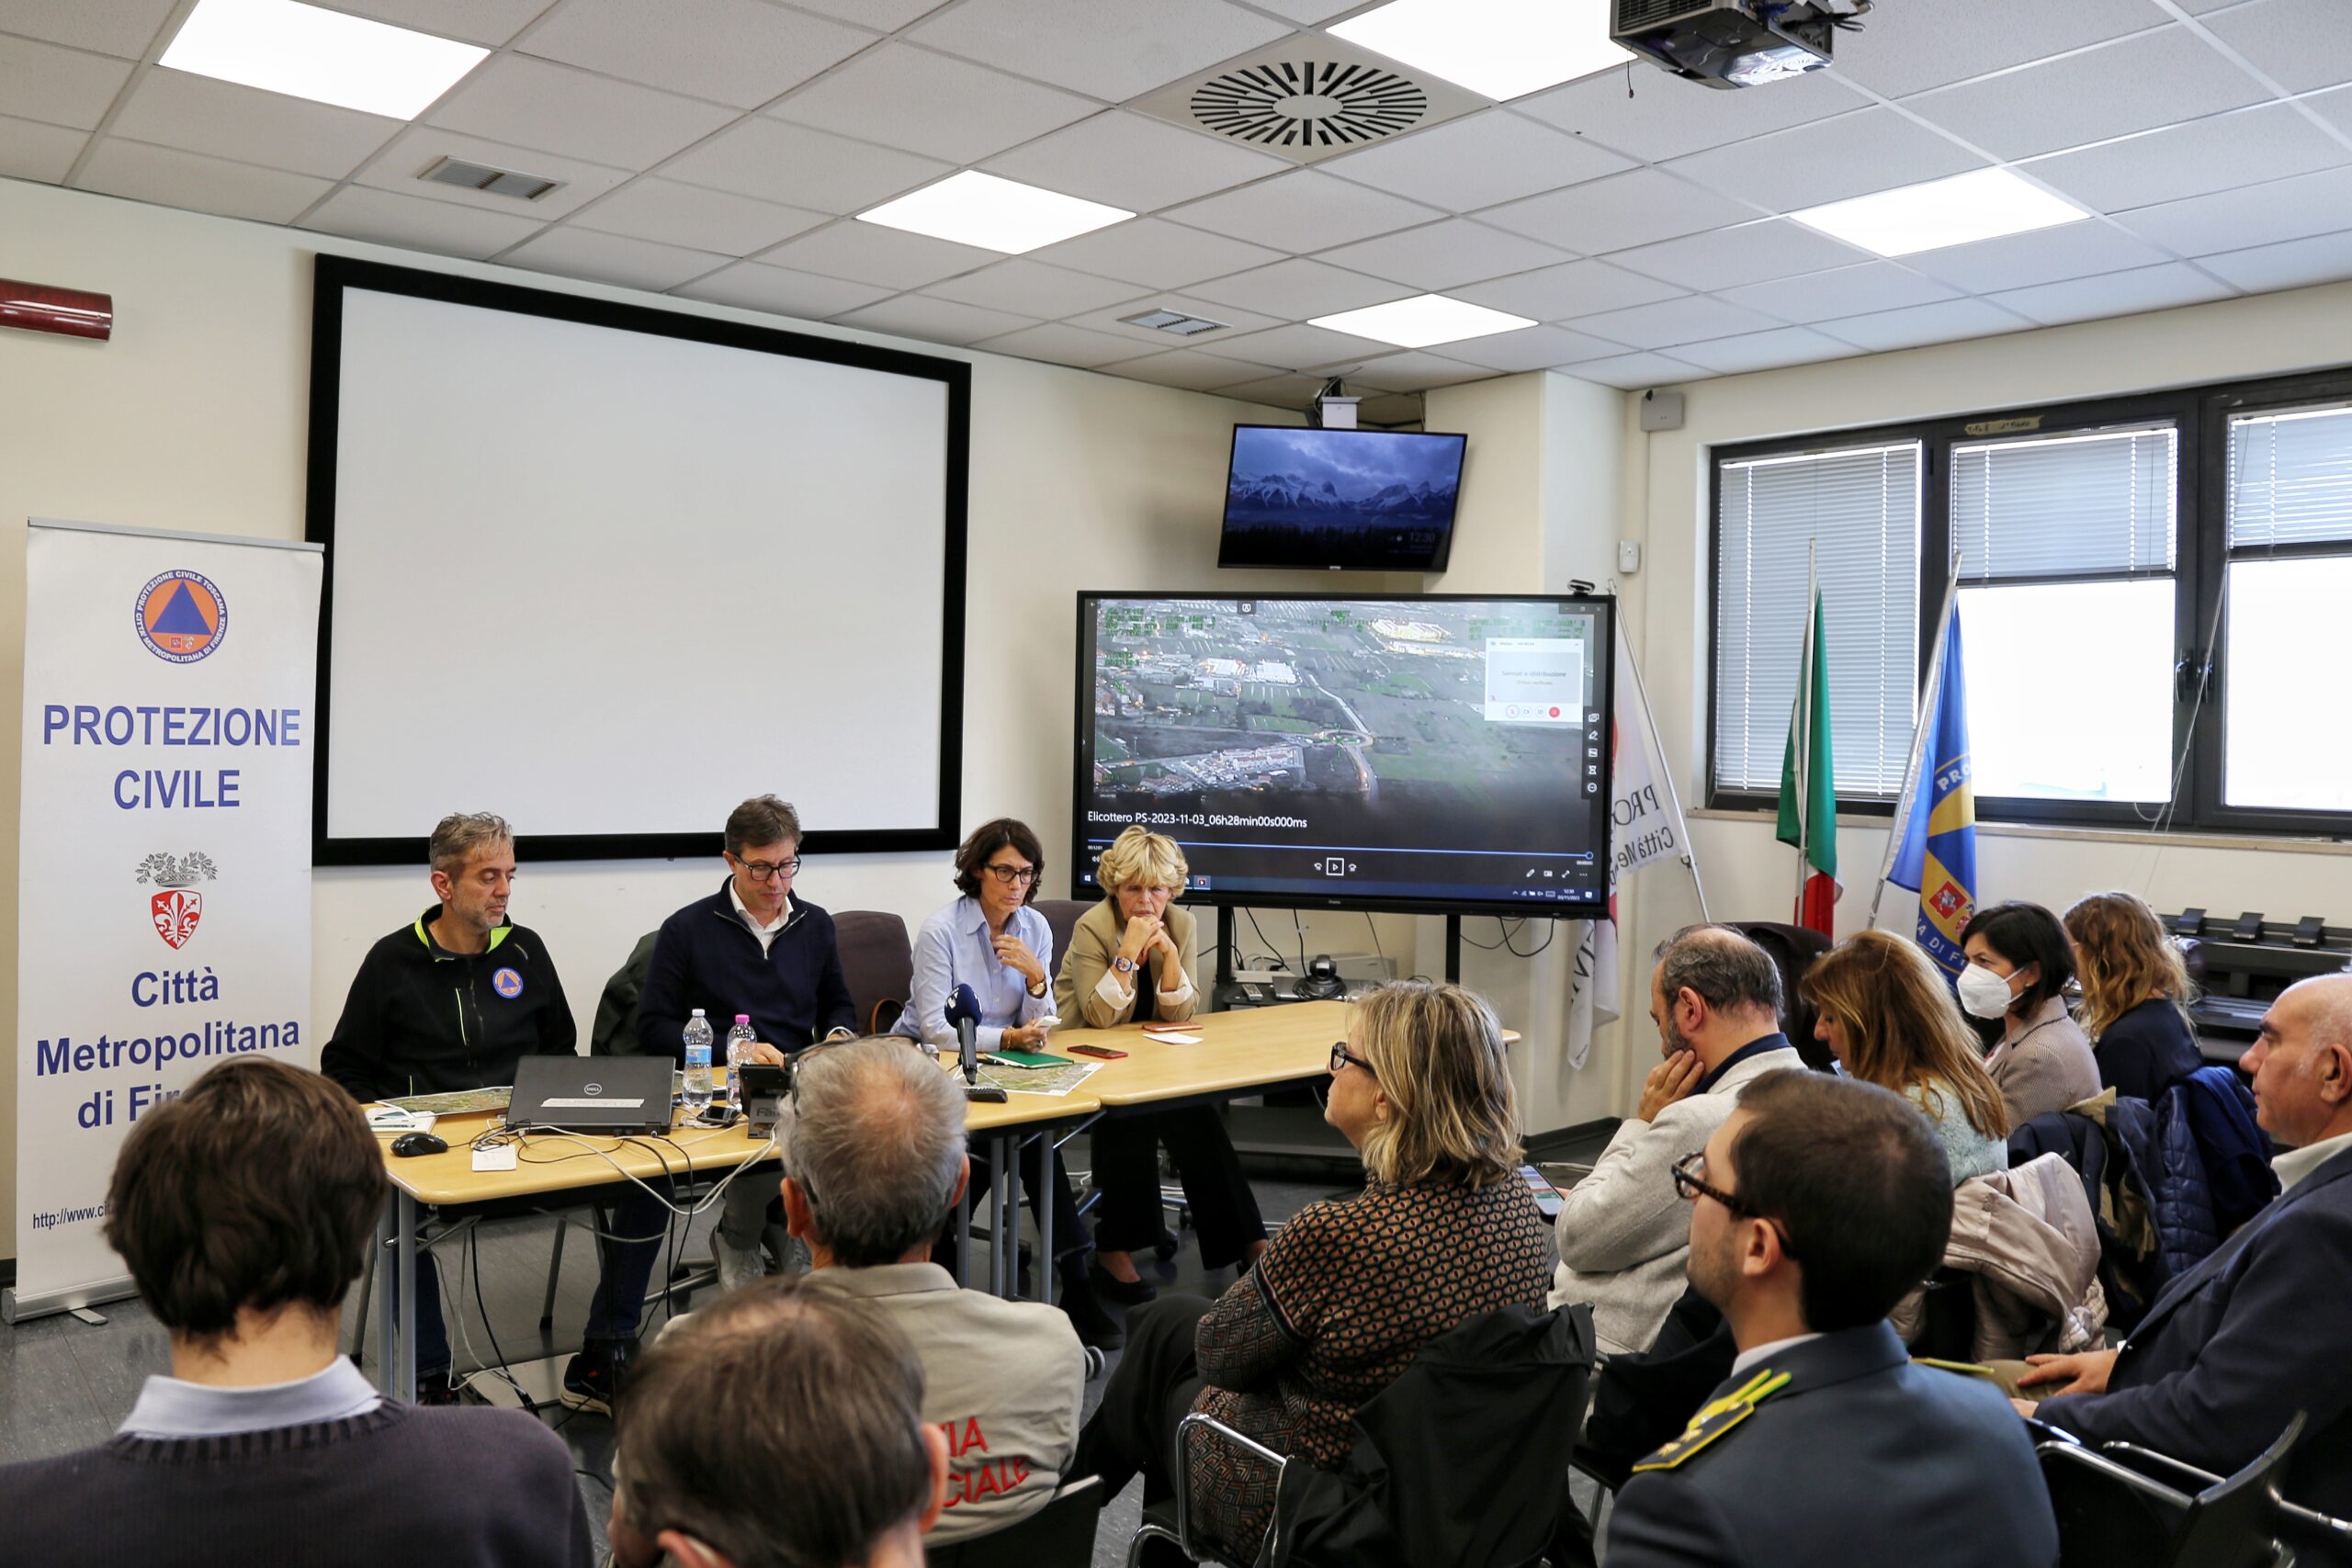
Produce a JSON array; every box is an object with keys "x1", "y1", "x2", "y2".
[{"x1": 1606, "y1": 1072, "x2": 2058, "y2": 1568}]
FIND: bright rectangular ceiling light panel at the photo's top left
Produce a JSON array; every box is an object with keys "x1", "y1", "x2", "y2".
[{"x1": 160, "y1": 0, "x2": 489, "y2": 120}]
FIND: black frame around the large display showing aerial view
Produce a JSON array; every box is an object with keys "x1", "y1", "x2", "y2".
[{"x1": 1070, "y1": 588, "x2": 1618, "y2": 919}]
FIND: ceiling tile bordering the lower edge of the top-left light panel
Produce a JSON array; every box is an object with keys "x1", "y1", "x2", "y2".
[{"x1": 110, "y1": 68, "x2": 400, "y2": 179}]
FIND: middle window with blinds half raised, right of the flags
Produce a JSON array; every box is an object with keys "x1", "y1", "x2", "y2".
[{"x1": 1950, "y1": 423, "x2": 2180, "y2": 804}]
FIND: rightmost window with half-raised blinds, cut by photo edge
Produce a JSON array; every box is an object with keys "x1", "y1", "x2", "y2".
[{"x1": 2221, "y1": 404, "x2": 2352, "y2": 811}]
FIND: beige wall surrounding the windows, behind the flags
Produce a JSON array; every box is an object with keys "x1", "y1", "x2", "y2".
[{"x1": 1625, "y1": 285, "x2": 2352, "y2": 1029}]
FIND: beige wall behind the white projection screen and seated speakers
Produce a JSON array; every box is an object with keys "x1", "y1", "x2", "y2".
[{"x1": 0, "y1": 181, "x2": 1414, "y2": 1258}]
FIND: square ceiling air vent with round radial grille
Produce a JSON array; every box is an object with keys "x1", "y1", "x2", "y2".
[{"x1": 1134, "y1": 33, "x2": 1487, "y2": 163}]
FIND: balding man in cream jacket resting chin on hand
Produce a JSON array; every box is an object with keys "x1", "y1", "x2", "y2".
[{"x1": 1550, "y1": 926, "x2": 1804, "y2": 1354}]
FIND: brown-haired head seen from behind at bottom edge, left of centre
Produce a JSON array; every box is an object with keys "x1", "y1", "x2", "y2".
[{"x1": 609, "y1": 1274, "x2": 948, "y2": 1568}]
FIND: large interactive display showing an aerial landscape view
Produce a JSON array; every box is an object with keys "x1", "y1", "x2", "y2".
[{"x1": 1072, "y1": 592, "x2": 1616, "y2": 917}]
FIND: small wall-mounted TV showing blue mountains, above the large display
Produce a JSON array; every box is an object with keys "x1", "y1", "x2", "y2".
[{"x1": 1216, "y1": 425, "x2": 1465, "y2": 571}]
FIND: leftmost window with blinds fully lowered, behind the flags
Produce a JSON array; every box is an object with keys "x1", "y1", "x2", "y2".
[{"x1": 1713, "y1": 440, "x2": 1922, "y2": 799}]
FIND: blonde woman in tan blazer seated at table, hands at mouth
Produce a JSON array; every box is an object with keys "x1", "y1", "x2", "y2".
[{"x1": 1054, "y1": 828, "x2": 1265, "y2": 1304}]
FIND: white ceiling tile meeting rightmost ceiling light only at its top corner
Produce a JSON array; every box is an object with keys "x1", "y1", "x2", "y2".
[{"x1": 1903, "y1": 26, "x2": 2269, "y2": 157}]
